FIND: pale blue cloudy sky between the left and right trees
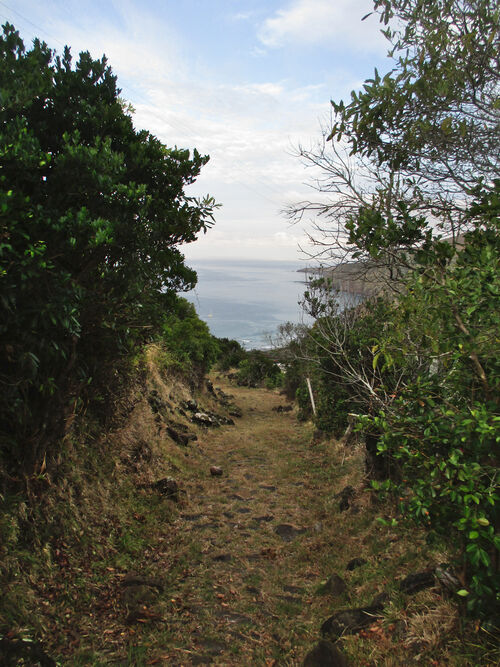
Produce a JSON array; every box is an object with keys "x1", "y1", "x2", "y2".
[{"x1": 0, "y1": 0, "x2": 390, "y2": 261}]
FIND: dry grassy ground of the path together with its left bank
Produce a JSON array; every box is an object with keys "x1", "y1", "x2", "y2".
[{"x1": 0, "y1": 347, "x2": 498, "y2": 666}]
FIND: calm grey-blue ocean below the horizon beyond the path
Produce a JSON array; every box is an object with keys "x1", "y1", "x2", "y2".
[{"x1": 182, "y1": 260, "x2": 310, "y2": 349}]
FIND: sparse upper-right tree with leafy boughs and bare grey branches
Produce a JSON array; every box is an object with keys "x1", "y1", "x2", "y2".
[{"x1": 289, "y1": 0, "x2": 500, "y2": 274}]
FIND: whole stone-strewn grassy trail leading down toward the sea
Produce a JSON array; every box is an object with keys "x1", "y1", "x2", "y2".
[{"x1": 7, "y1": 376, "x2": 473, "y2": 667}]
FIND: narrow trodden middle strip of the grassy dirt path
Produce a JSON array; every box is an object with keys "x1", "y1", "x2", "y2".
[{"x1": 129, "y1": 381, "x2": 358, "y2": 665}]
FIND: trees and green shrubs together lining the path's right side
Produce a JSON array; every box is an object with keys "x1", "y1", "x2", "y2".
[{"x1": 290, "y1": 0, "x2": 500, "y2": 617}]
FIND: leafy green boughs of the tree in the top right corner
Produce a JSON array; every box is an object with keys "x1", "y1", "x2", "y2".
[{"x1": 330, "y1": 0, "x2": 500, "y2": 189}]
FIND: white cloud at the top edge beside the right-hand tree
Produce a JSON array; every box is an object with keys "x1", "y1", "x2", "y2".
[{"x1": 258, "y1": 0, "x2": 387, "y2": 52}]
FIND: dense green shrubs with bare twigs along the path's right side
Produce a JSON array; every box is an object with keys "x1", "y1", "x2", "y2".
[{"x1": 286, "y1": 183, "x2": 500, "y2": 618}]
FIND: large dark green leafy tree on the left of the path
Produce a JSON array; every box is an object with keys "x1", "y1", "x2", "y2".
[{"x1": 0, "y1": 24, "x2": 218, "y2": 467}]
